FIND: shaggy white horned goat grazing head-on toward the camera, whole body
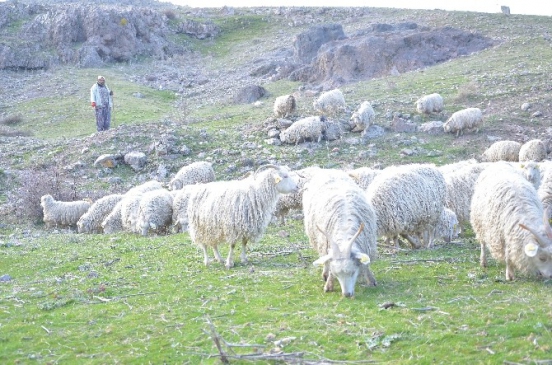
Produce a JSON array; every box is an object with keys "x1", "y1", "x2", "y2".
[{"x1": 303, "y1": 172, "x2": 377, "y2": 297}]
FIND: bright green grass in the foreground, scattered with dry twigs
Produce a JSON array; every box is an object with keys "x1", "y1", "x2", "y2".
[{"x1": 0, "y1": 222, "x2": 552, "y2": 364}]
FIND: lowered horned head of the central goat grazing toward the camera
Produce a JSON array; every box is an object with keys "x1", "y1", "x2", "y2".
[{"x1": 313, "y1": 224, "x2": 370, "y2": 297}]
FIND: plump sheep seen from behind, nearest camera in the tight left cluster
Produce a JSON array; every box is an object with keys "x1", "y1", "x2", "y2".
[{"x1": 136, "y1": 189, "x2": 173, "y2": 236}]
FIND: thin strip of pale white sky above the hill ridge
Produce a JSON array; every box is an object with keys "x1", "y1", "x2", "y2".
[{"x1": 161, "y1": 0, "x2": 552, "y2": 16}]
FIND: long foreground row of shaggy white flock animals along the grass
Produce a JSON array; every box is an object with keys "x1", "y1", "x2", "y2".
[{"x1": 41, "y1": 132, "x2": 552, "y2": 297}]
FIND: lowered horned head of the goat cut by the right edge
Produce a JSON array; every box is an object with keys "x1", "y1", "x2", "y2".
[{"x1": 519, "y1": 210, "x2": 552, "y2": 278}]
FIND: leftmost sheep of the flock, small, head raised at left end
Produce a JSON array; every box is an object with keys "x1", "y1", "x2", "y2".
[{"x1": 40, "y1": 194, "x2": 91, "y2": 227}]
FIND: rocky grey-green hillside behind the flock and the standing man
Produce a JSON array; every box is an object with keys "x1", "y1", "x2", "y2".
[{"x1": 0, "y1": 1, "x2": 552, "y2": 229}]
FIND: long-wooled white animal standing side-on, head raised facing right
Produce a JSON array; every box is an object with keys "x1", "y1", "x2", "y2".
[{"x1": 187, "y1": 165, "x2": 298, "y2": 269}]
